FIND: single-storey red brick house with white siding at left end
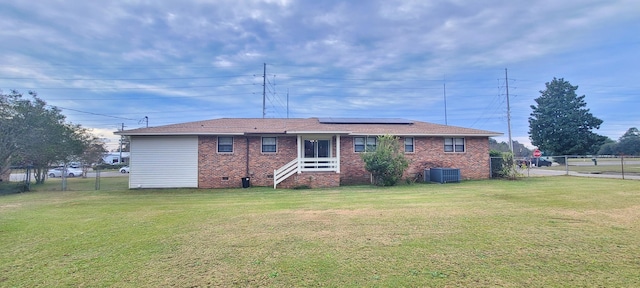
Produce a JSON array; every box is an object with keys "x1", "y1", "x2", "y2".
[{"x1": 115, "y1": 118, "x2": 502, "y2": 188}]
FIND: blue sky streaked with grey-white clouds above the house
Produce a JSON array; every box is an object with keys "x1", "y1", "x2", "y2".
[{"x1": 0, "y1": 0, "x2": 640, "y2": 151}]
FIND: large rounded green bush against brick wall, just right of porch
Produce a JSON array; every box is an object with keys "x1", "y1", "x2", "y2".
[{"x1": 360, "y1": 135, "x2": 409, "y2": 186}]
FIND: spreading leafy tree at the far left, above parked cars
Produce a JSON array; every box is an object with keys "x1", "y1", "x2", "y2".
[{"x1": 0, "y1": 90, "x2": 107, "y2": 184}]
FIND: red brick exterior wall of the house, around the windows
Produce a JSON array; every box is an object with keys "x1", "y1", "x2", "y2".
[{"x1": 198, "y1": 136, "x2": 489, "y2": 188}]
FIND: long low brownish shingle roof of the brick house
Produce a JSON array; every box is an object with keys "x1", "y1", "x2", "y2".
[{"x1": 115, "y1": 118, "x2": 503, "y2": 137}]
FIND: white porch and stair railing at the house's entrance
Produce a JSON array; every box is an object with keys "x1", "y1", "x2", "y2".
[{"x1": 273, "y1": 158, "x2": 339, "y2": 189}]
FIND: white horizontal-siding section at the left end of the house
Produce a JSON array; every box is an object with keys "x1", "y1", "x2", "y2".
[{"x1": 129, "y1": 136, "x2": 198, "y2": 188}]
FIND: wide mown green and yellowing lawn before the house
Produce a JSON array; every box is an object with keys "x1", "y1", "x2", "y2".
[{"x1": 0, "y1": 176, "x2": 640, "y2": 287}]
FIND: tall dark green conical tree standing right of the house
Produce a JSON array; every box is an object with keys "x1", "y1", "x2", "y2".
[{"x1": 529, "y1": 78, "x2": 606, "y2": 155}]
